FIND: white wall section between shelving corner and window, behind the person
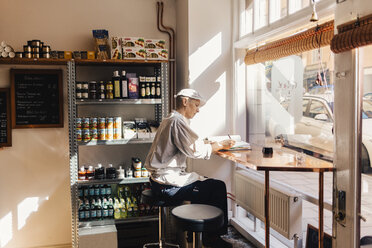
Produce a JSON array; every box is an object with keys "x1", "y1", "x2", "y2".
[{"x1": 188, "y1": 0, "x2": 233, "y2": 190}]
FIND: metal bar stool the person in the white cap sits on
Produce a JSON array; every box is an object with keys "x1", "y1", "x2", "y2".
[{"x1": 142, "y1": 189, "x2": 180, "y2": 248}]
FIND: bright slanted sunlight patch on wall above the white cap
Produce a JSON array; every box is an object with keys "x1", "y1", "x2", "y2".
[{"x1": 189, "y1": 32, "x2": 222, "y2": 85}]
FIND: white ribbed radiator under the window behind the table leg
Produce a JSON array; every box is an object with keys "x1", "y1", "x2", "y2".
[{"x1": 235, "y1": 170, "x2": 302, "y2": 239}]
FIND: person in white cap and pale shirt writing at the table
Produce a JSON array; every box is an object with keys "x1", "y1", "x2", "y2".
[{"x1": 145, "y1": 89, "x2": 234, "y2": 247}]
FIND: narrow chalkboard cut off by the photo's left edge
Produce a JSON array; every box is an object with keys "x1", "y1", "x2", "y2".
[{"x1": 0, "y1": 89, "x2": 12, "y2": 147}]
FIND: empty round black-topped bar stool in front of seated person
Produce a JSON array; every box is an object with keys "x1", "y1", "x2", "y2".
[{"x1": 172, "y1": 204, "x2": 224, "y2": 248}]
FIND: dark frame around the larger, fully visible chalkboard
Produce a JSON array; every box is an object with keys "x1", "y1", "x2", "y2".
[{"x1": 10, "y1": 69, "x2": 63, "y2": 129}]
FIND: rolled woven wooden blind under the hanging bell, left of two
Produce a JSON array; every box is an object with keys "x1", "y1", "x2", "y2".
[{"x1": 244, "y1": 20, "x2": 334, "y2": 65}]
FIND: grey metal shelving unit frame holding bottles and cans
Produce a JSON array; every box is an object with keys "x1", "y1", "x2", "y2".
[{"x1": 67, "y1": 60, "x2": 169, "y2": 247}]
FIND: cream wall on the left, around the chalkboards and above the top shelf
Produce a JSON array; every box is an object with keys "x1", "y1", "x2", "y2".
[{"x1": 0, "y1": 0, "x2": 176, "y2": 248}]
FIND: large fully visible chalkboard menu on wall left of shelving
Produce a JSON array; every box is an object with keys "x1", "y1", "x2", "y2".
[{"x1": 10, "y1": 69, "x2": 63, "y2": 128}]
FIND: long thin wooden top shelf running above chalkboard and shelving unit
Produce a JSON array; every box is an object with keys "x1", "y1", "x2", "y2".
[{"x1": 0, "y1": 58, "x2": 168, "y2": 66}]
